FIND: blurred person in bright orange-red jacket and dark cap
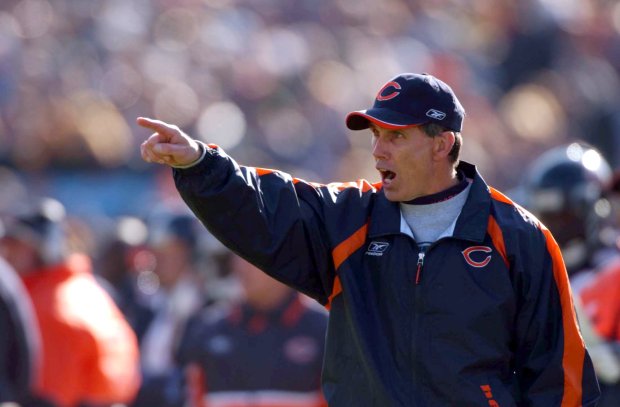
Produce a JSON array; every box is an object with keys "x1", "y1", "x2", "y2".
[{"x1": 0, "y1": 198, "x2": 140, "y2": 407}]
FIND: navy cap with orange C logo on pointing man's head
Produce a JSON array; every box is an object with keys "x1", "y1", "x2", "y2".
[{"x1": 346, "y1": 73, "x2": 465, "y2": 132}]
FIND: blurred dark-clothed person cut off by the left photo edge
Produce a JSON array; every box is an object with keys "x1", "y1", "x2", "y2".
[{"x1": 0, "y1": 258, "x2": 41, "y2": 406}]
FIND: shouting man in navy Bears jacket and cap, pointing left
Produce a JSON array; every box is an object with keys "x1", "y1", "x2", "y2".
[{"x1": 138, "y1": 74, "x2": 599, "y2": 407}]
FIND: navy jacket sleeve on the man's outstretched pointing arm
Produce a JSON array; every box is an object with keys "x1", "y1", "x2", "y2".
[{"x1": 173, "y1": 146, "x2": 344, "y2": 304}]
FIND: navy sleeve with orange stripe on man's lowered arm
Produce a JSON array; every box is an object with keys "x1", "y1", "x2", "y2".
[{"x1": 515, "y1": 224, "x2": 600, "y2": 407}]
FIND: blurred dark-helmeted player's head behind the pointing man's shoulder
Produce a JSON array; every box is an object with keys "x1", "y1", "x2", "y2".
[{"x1": 524, "y1": 142, "x2": 615, "y2": 288}]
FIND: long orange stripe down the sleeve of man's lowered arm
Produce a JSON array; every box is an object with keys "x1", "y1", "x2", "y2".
[{"x1": 541, "y1": 226, "x2": 585, "y2": 407}]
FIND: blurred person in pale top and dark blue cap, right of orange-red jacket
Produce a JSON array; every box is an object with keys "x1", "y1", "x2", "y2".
[{"x1": 132, "y1": 213, "x2": 210, "y2": 407}]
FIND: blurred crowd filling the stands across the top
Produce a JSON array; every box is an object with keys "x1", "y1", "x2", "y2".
[{"x1": 0, "y1": 0, "x2": 620, "y2": 198}]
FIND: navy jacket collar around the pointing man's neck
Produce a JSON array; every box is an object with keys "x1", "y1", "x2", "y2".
[{"x1": 368, "y1": 161, "x2": 491, "y2": 242}]
